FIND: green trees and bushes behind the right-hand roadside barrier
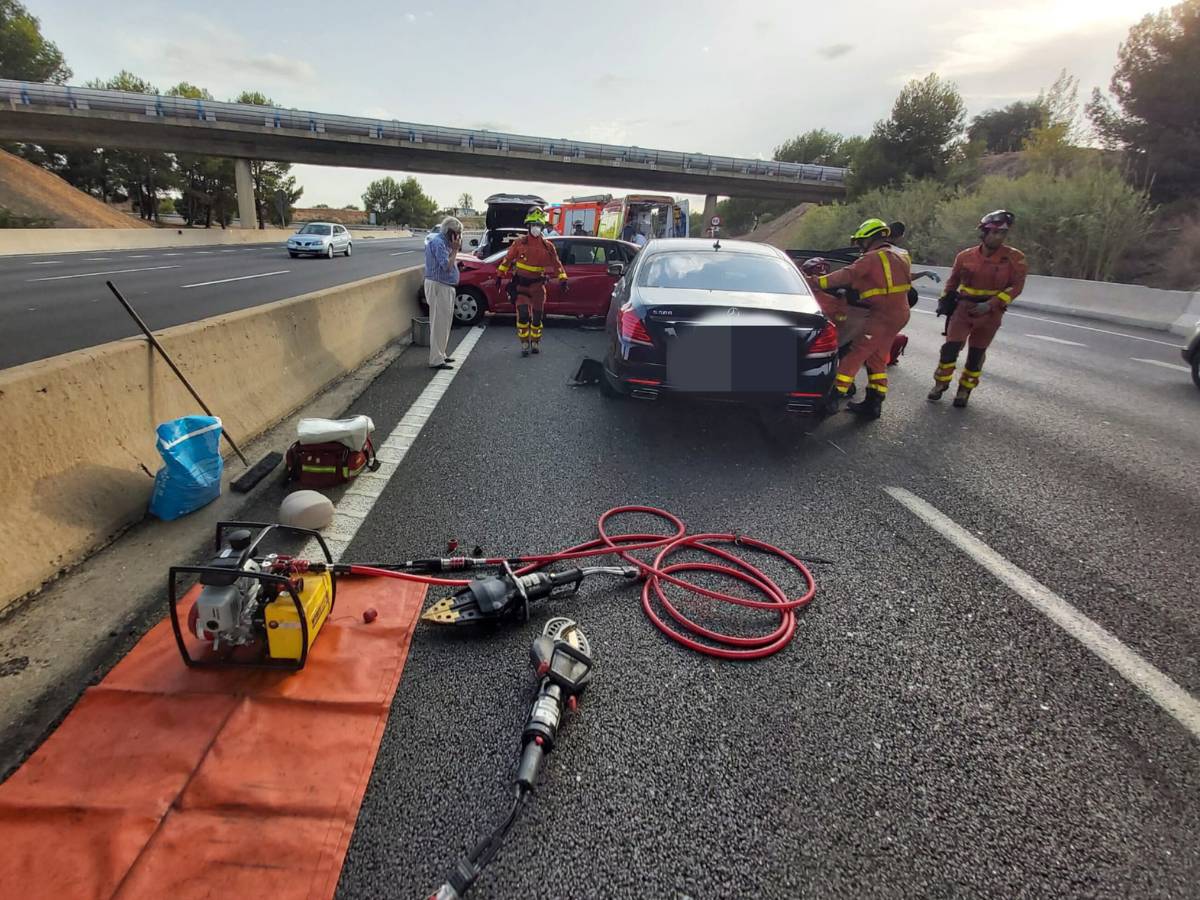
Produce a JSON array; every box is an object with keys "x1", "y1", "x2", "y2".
[{"x1": 719, "y1": 0, "x2": 1200, "y2": 289}]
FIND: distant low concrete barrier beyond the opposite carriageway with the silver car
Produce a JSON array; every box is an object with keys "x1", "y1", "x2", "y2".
[{"x1": 0, "y1": 228, "x2": 413, "y2": 257}]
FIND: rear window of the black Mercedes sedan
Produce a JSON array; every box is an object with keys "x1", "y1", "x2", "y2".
[{"x1": 637, "y1": 250, "x2": 808, "y2": 294}]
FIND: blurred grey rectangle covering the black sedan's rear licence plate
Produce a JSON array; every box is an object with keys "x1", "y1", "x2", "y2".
[{"x1": 667, "y1": 325, "x2": 798, "y2": 394}]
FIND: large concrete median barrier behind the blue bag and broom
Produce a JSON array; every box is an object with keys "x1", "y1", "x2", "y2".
[{"x1": 0, "y1": 268, "x2": 421, "y2": 610}]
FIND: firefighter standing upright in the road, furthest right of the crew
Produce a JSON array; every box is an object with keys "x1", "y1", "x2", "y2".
[{"x1": 929, "y1": 209, "x2": 1027, "y2": 409}]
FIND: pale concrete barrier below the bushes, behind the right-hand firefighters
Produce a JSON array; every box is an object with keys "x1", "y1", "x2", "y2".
[{"x1": 913, "y1": 270, "x2": 1200, "y2": 336}]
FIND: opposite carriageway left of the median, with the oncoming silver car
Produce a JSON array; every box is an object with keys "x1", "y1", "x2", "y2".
[{"x1": 0, "y1": 238, "x2": 422, "y2": 368}]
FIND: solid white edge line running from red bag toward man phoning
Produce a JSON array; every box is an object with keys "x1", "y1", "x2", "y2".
[{"x1": 301, "y1": 326, "x2": 484, "y2": 563}]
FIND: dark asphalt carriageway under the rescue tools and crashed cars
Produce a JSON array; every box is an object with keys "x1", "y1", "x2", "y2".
[{"x1": 302, "y1": 301, "x2": 1200, "y2": 900}]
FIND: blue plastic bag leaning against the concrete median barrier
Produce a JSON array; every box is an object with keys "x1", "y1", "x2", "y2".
[{"x1": 150, "y1": 415, "x2": 224, "y2": 522}]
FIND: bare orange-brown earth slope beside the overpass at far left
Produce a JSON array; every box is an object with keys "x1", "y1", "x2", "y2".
[{"x1": 0, "y1": 151, "x2": 150, "y2": 228}]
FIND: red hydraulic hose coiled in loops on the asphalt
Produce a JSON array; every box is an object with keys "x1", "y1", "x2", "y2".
[{"x1": 349, "y1": 506, "x2": 816, "y2": 659}]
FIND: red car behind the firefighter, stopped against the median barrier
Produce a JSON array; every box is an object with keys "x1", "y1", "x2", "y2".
[{"x1": 419, "y1": 236, "x2": 638, "y2": 325}]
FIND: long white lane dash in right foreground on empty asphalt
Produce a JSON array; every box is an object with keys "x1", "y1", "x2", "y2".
[{"x1": 883, "y1": 487, "x2": 1200, "y2": 738}]
